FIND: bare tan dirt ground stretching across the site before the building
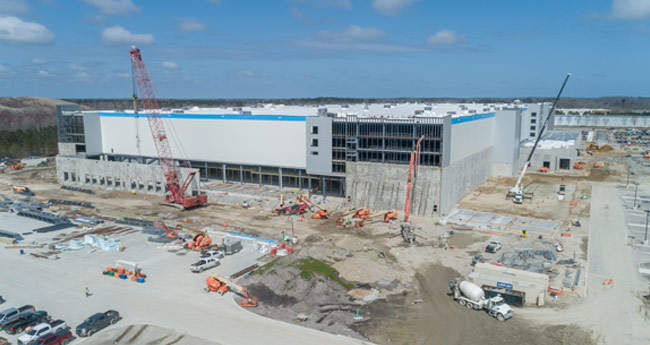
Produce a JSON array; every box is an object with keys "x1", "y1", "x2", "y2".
[{"x1": 0, "y1": 144, "x2": 636, "y2": 345}]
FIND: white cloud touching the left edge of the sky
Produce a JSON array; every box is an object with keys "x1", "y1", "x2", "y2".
[{"x1": 0, "y1": 15, "x2": 54, "y2": 43}]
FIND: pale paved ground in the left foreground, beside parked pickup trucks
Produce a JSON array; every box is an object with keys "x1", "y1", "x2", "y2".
[{"x1": 0, "y1": 242, "x2": 367, "y2": 345}]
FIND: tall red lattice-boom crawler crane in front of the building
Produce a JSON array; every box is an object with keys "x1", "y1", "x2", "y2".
[{"x1": 129, "y1": 46, "x2": 208, "y2": 209}]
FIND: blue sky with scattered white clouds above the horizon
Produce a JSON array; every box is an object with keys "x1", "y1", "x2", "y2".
[{"x1": 0, "y1": 0, "x2": 650, "y2": 98}]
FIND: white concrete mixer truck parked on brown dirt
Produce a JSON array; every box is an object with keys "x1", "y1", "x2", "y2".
[{"x1": 449, "y1": 278, "x2": 513, "y2": 321}]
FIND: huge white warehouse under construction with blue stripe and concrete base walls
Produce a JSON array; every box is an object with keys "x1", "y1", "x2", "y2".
[{"x1": 57, "y1": 103, "x2": 553, "y2": 215}]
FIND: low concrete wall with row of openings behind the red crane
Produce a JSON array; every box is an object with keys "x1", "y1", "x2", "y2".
[{"x1": 56, "y1": 156, "x2": 199, "y2": 195}]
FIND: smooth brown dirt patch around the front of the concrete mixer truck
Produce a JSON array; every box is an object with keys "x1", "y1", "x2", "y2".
[{"x1": 355, "y1": 265, "x2": 594, "y2": 345}]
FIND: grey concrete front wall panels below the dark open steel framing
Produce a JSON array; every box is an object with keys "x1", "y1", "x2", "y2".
[{"x1": 346, "y1": 162, "x2": 440, "y2": 217}]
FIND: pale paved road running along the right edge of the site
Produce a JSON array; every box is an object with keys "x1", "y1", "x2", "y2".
[{"x1": 519, "y1": 184, "x2": 650, "y2": 345}]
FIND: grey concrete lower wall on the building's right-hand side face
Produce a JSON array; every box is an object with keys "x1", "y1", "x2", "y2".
[{"x1": 439, "y1": 146, "x2": 492, "y2": 214}]
